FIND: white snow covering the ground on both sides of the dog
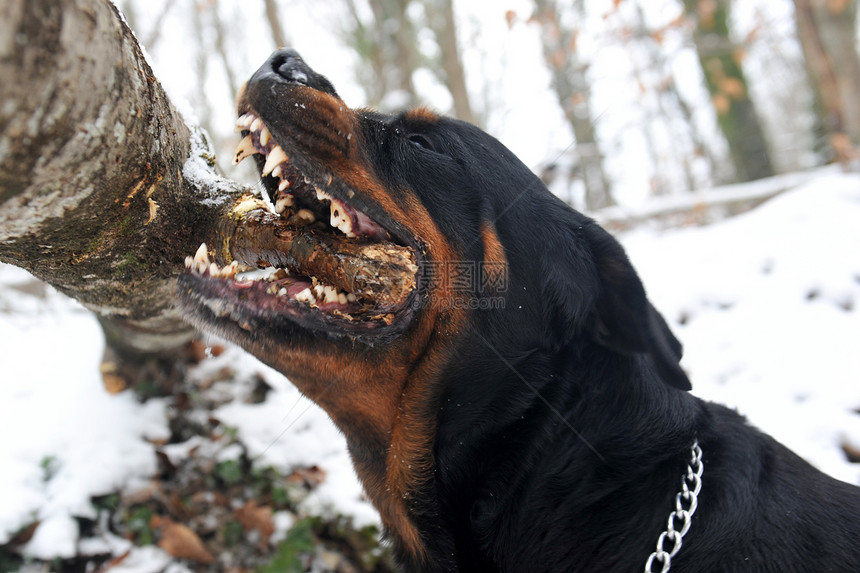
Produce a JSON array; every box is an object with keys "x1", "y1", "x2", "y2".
[{"x1": 0, "y1": 170, "x2": 860, "y2": 573}]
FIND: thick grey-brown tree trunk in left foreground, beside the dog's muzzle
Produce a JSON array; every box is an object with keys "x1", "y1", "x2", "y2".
[{"x1": 0, "y1": 0, "x2": 244, "y2": 374}]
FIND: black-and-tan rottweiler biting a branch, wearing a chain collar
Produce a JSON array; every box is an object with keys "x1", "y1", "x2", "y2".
[{"x1": 179, "y1": 51, "x2": 860, "y2": 573}]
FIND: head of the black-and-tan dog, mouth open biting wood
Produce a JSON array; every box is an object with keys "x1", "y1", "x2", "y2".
[{"x1": 179, "y1": 50, "x2": 689, "y2": 553}]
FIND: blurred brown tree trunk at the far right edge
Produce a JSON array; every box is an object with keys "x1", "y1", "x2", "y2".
[{"x1": 794, "y1": 0, "x2": 860, "y2": 160}]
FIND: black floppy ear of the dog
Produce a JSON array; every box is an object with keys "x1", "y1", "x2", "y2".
[{"x1": 580, "y1": 221, "x2": 692, "y2": 390}]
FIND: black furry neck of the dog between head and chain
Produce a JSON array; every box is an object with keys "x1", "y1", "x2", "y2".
[{"x1": 435, "y1": 345, "x2": 700, "y2": 571}]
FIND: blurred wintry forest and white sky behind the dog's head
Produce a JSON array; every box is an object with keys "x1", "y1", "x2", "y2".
[{"x1": 112, "y1": 0, "x2": 860, "y2": 217}]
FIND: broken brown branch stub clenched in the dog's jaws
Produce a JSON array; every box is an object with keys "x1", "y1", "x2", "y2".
[{"x1": 225, "y1": 209, "x2": 418, "y2": 308}]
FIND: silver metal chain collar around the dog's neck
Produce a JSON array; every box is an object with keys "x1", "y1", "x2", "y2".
[{"x1": 645, "y1": 440, "x2": 705, "y2": 573}]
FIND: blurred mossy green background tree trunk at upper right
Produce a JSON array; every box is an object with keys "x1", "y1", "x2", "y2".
[{"x1": 684, "y1": 0, "x2": 773, "y2": 181}]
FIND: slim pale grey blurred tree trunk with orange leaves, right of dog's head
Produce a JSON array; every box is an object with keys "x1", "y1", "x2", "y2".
[{"x1": 533, "y1": 0, "x2": 615, "y2": 210}]
